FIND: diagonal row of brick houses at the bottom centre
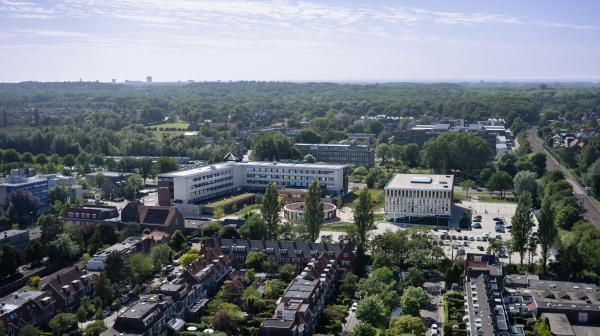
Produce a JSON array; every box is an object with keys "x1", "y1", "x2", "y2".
[{"x1": 259, "y1": 253, "x2": 338, "y2": 336}]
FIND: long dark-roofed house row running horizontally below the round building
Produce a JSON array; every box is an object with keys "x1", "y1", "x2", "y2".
[{"x1": 208, "y1": 237, "x2": 354, "y2": 271}]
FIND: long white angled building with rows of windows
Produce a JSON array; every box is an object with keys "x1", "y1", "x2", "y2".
[{"x1": 158, "y1": 161, "x2": 346, "y2": 204}]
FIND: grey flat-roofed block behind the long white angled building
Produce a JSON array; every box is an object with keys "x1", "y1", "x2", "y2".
[{"x1": 296, "y1": 143, "x2": 375, "y2": 168}]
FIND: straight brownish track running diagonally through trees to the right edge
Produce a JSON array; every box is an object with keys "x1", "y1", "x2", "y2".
[{"x1": 527, "y1": 127, "x2": 600, "y2": 226}]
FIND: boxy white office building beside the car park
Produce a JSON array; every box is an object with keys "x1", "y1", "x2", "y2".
[{"x1": 384, "y1": 174, "x2": 454, "y2": 222}]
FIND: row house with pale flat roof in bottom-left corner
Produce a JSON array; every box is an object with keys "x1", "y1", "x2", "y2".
[{"x1": 0, "y1": 291, "x2": 55, "y2": 336}]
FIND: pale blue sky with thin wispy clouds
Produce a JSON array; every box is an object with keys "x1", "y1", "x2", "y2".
[{"x1": 0, "y1": 0, "x2": 600, "y2": 82}]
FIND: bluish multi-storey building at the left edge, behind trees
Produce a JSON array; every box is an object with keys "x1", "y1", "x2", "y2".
[{"x1": 0, "y1": 168, "x2": 50, "y2": 212}]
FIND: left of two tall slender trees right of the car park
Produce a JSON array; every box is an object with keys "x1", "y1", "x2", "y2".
[{"x1": 511, "y1": 191, "x2": 535, "y2": 265}]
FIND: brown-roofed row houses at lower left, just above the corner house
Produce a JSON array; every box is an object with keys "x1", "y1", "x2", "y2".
[{"x1": 40, "y1": 266, "x2": 98, "y2": 313}]
